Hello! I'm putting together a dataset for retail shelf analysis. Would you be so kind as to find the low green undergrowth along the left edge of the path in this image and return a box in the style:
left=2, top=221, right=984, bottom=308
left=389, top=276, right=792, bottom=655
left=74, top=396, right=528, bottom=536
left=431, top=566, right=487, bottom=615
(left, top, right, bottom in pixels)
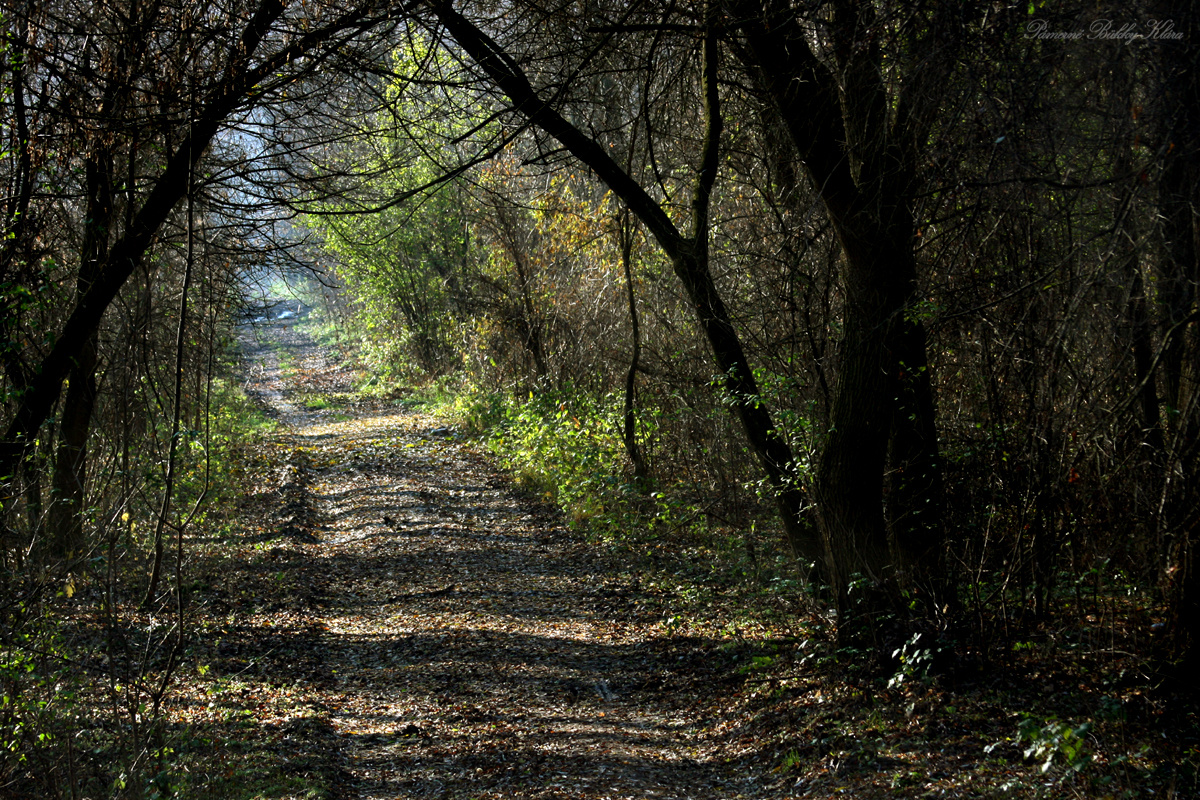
left=0, top=380, right=272, bottom=799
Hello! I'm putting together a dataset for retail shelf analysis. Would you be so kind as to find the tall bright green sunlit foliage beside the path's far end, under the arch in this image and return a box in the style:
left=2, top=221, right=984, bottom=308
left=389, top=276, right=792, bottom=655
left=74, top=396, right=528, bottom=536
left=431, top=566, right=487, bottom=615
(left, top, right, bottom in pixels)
left=301, top=37, right=494, bottom=377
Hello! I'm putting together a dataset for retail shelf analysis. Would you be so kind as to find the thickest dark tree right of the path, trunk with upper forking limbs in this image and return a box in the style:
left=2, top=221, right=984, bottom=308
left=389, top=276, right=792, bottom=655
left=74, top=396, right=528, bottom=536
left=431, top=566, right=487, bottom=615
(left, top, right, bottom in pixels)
left=732, top=0, right=950, bottom=627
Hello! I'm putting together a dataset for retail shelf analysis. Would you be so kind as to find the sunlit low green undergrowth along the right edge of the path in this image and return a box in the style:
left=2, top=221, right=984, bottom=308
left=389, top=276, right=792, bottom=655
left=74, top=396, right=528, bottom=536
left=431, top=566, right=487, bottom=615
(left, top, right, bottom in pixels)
left=432, top=385, right=800, bottom=593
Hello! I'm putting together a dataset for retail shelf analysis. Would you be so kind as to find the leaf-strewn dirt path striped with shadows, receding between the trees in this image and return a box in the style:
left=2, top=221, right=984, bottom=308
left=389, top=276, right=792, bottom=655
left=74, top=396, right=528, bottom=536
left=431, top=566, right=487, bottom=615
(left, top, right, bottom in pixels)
left=224, top=303, right=762, bottom=800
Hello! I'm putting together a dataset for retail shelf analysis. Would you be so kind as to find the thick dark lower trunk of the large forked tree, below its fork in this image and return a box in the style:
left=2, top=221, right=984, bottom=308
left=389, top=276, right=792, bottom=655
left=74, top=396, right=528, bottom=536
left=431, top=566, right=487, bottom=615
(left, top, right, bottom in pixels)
left=817, top=219, right=944, bottom=622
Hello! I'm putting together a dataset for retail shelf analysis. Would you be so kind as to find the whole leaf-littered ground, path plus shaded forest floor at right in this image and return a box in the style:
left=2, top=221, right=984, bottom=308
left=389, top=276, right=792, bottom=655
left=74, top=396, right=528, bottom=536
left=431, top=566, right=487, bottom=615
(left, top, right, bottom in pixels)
left=168, top=309, right=1200, bottom=800
